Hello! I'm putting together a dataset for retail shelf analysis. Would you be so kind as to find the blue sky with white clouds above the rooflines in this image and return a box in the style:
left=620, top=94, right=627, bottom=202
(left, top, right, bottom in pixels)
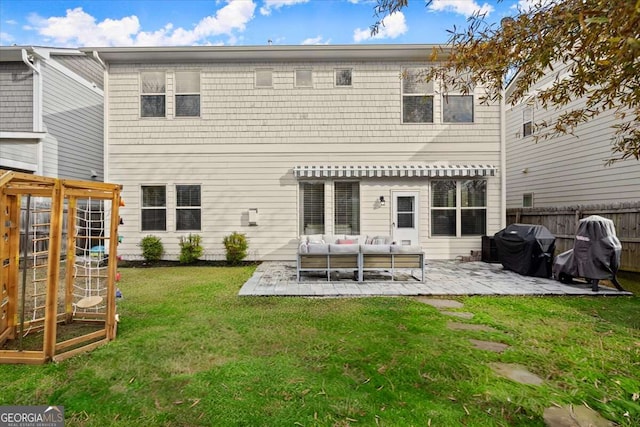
left=0, top=0, right=534, bottom=47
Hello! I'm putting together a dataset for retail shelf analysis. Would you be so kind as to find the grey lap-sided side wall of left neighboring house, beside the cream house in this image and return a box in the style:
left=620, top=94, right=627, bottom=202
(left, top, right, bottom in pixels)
left=41, top=63, right=104, bottom=180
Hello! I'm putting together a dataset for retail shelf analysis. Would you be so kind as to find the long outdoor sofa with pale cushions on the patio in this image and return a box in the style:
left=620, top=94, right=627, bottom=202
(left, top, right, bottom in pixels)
left=296, top=234, right=424, bottom=282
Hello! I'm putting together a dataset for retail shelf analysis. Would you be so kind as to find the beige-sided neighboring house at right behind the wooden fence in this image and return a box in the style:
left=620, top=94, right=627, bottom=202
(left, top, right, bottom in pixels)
left=505, top=62, right=640, bottom=211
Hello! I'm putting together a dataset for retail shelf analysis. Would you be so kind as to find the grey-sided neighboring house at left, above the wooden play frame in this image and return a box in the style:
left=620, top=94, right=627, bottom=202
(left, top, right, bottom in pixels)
left=0, top=46, right=104, bottom=181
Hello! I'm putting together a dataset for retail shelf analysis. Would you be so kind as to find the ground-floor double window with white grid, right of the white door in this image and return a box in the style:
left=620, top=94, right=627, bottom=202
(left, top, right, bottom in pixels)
left=431, top=179, right=487, bottom=237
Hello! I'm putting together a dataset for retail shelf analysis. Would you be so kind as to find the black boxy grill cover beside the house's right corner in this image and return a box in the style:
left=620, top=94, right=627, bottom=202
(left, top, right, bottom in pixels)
left=494, top=224, right=556, bottom=277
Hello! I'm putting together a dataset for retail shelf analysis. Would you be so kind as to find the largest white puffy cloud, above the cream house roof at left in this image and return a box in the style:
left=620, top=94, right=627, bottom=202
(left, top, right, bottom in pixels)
left=25, top=0, right=256, bottom=46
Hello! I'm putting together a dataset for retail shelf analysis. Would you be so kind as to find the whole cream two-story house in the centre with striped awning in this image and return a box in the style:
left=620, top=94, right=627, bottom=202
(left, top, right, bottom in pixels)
left=81, top=45, right=505, bottom=260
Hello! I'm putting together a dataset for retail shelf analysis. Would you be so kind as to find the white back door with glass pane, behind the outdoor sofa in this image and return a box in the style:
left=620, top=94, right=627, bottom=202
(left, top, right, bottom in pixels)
left=391, top=191, right=420, bottom=245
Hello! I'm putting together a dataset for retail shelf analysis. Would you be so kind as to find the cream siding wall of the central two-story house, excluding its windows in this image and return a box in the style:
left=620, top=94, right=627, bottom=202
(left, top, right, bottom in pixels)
left=106, top=54, right=501, bottom=260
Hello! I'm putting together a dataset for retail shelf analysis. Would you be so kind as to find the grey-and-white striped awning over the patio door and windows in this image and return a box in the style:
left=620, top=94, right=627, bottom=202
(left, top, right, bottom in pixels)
left=293, top=163, right=497, bottom=178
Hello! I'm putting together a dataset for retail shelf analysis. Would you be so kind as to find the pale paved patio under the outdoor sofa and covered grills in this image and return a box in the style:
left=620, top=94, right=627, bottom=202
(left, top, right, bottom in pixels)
left=239, top=260, right=633, bottom=297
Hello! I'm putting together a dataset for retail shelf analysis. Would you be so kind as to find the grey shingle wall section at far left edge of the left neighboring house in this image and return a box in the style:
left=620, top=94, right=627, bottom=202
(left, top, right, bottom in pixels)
left=0, top=62, right=33, bottom=132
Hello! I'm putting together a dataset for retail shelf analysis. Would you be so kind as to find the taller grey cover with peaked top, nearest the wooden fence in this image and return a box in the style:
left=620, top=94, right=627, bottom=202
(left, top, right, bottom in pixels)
left=553, top=215, right=622, bottom=280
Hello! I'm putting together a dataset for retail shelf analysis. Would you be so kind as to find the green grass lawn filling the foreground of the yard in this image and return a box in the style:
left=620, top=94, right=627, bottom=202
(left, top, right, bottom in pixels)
left=0, top=267, right=640, bottom=427
